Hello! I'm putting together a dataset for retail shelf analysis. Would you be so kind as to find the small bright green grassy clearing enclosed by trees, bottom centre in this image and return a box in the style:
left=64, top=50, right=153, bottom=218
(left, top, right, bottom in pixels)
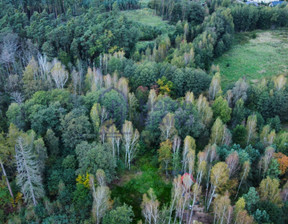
left=111, top=152, right=172, bottom=223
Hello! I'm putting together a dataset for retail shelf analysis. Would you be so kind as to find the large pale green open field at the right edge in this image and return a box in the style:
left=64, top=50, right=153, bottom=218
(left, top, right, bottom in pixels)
left=214, top=29, right=288, bottom=85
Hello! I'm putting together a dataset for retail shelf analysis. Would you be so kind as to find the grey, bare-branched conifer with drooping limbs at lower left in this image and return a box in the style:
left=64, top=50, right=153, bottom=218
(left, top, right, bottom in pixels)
left=15, top=137, right=44, bottom=206
